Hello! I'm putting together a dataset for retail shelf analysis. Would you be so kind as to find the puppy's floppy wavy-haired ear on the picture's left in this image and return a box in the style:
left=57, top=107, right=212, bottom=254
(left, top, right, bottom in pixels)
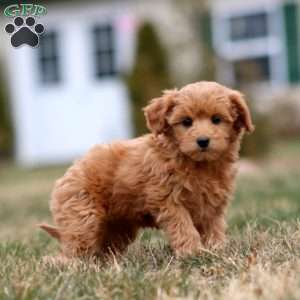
left=143, top=90, right=178, bottom=134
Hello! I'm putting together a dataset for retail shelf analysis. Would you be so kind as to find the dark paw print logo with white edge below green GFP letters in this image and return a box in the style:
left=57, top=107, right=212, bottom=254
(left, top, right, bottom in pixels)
left=5, top=17, right=45, bottom=47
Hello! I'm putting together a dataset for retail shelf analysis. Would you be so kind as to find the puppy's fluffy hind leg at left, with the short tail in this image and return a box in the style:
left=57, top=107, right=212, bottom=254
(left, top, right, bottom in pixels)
left=50, top=189, right=106, bottom=257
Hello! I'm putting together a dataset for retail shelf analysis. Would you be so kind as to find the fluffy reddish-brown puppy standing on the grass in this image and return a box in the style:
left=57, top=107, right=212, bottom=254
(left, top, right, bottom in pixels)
left=41, top=82, right=253, bottom=257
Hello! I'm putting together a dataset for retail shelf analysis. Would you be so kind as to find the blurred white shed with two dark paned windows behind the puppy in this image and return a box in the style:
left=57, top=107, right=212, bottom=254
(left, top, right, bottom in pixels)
left=1, top=2, right=136, bottom=166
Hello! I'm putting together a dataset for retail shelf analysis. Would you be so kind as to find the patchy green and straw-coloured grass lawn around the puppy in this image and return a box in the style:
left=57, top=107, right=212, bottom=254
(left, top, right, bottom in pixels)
left=0, top=141, right=300, bottom=300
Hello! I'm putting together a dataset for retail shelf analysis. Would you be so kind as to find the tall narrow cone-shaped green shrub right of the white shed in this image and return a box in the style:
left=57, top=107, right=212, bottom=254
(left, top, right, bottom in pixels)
left=127, top=23, right=171, bottom=135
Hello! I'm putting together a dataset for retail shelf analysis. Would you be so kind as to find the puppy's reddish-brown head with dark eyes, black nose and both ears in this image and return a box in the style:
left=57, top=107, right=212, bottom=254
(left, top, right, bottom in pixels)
left=144, top=82, right=254, bottom=161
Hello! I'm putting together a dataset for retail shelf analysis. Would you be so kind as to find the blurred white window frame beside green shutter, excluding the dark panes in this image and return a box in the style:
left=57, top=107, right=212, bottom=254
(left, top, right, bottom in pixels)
left=212, top=2, right=287, bottom=86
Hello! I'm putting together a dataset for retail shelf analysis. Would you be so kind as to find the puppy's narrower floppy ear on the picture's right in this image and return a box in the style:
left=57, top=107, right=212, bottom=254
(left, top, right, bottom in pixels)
left=229, top=91, right=254, bottom=133
